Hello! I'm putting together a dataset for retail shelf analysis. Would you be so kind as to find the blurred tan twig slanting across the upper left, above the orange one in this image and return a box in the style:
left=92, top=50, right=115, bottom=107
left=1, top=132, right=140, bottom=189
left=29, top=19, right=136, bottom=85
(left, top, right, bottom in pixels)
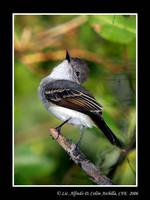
left=14, top=15, right=88, bottom=52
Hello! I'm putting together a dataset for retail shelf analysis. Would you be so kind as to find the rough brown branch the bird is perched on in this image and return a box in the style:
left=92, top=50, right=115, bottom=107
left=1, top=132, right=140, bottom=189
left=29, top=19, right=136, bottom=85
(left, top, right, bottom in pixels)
left=50, top=128, right=112, bottom=185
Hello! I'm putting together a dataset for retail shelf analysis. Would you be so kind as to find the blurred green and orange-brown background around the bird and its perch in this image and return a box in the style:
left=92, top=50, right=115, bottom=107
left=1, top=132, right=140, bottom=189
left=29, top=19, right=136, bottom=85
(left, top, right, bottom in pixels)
left=14, top=15, right=136, bottom=185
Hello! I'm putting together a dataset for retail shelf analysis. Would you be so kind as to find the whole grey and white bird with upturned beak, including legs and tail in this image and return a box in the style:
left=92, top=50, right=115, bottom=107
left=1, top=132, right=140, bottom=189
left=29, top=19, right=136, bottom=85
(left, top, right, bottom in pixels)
left=38, top=50, right=123, bottom=148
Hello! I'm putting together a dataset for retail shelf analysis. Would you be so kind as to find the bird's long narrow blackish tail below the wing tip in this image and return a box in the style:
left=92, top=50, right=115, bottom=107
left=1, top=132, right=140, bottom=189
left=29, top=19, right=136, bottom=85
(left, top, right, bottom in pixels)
left=91, top=113, right=124, bottom=148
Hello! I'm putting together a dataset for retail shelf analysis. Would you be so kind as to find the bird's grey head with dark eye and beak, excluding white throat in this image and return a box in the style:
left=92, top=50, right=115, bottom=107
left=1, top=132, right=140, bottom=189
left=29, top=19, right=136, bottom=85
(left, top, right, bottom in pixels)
left=66, top=51, right=88, bottom=84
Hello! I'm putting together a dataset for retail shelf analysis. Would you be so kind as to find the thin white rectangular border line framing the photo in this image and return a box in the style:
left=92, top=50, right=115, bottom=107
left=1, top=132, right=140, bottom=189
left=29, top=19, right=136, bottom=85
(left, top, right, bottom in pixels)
left=12, top=13, right=138, bottom=188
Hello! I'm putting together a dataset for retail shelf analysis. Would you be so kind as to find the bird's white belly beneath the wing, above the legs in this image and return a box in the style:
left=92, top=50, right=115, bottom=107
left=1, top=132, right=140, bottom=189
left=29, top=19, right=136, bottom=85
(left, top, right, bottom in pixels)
left=48, top=104, right=93, bottom=128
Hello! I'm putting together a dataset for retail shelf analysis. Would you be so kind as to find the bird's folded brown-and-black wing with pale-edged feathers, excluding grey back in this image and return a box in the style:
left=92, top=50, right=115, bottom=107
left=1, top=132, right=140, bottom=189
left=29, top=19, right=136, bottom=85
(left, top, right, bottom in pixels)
left=45, top=88, right=102, bottom=113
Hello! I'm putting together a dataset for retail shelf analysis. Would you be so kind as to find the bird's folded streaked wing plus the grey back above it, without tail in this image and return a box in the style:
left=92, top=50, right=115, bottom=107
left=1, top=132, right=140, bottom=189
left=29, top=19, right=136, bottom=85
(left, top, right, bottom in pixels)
left=44, top=81, right=102, bottom=114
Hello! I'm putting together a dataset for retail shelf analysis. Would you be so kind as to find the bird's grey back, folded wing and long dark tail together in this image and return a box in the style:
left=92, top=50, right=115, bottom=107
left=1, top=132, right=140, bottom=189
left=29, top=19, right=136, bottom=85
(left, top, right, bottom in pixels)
left=44, top=80, right=121, bottom=147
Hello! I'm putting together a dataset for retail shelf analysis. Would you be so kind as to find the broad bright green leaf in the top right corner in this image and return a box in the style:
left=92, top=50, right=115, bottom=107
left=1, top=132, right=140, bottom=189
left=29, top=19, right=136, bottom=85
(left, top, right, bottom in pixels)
left=89, top=15, right=136, bottom=44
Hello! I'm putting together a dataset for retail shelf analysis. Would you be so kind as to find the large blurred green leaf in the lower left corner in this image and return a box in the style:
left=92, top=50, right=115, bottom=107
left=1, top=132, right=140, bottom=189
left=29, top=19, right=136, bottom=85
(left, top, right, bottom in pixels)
left=15, top=152, right=56, bottom=184
